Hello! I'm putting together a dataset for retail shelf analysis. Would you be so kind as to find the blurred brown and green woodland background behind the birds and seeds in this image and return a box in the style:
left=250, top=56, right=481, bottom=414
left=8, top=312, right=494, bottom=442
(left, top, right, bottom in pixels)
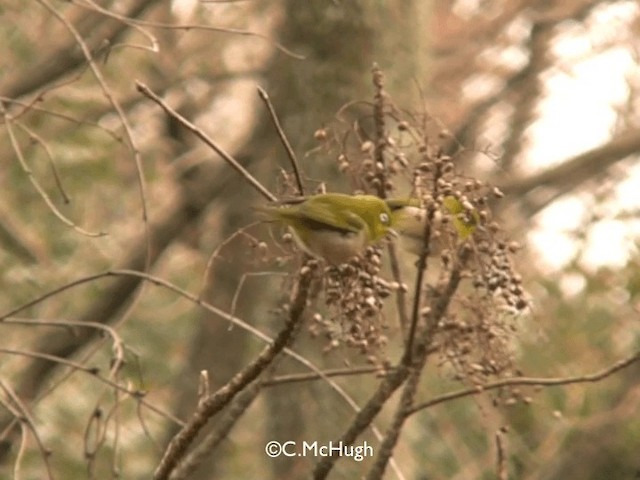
left=0, top=0, right=640, bottom=479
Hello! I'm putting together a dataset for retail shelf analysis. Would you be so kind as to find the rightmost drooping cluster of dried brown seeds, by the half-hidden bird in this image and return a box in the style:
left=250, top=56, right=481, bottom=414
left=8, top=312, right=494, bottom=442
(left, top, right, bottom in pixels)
left=415, top=163, right=528, bottom=384
